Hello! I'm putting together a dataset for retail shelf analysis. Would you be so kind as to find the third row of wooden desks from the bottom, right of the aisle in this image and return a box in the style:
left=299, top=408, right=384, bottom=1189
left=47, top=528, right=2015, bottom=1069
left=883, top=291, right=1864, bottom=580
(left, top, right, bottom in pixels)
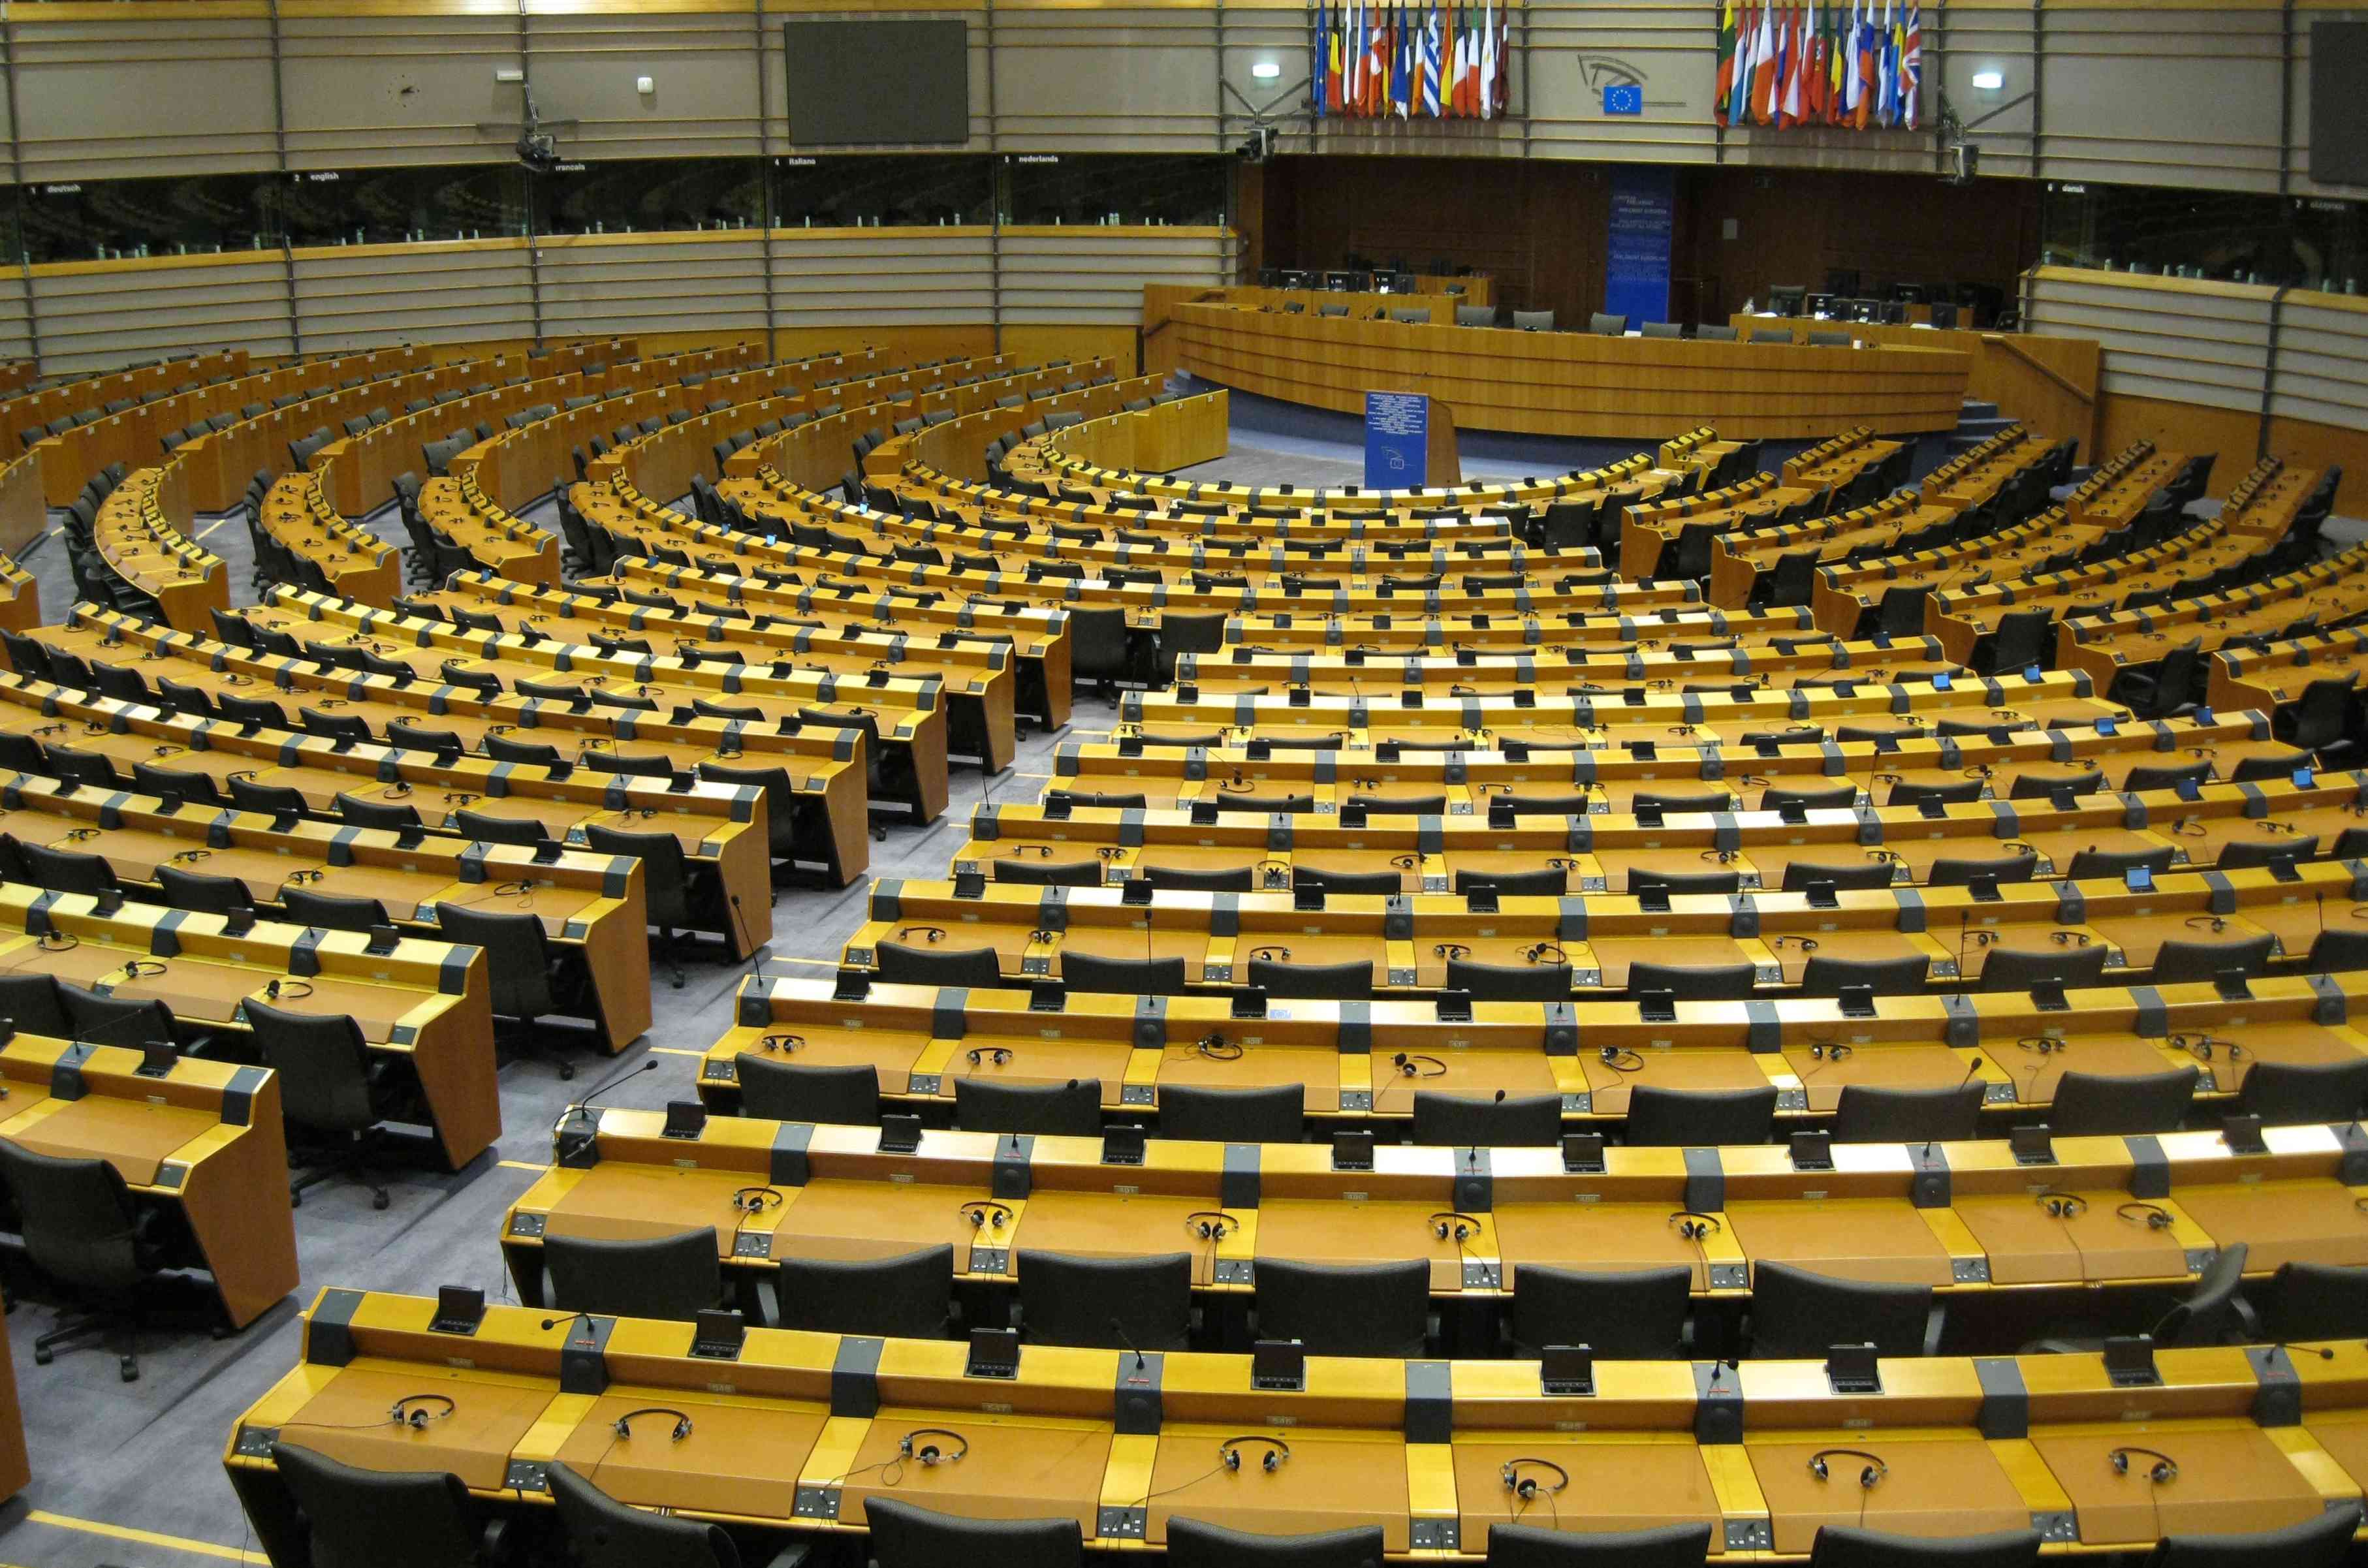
left=699, top=976, right=2363, bottom=1130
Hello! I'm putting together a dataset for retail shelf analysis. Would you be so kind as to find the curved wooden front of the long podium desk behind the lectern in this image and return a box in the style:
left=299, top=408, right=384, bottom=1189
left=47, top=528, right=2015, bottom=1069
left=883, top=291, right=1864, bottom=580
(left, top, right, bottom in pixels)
left=1172, top=306, right=1970, bottom=441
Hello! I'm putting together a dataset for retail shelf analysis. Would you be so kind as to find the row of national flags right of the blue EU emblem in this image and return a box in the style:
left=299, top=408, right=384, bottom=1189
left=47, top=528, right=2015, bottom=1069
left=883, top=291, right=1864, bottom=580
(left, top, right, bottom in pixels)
left=1712, top=0, right=1923, bottom=131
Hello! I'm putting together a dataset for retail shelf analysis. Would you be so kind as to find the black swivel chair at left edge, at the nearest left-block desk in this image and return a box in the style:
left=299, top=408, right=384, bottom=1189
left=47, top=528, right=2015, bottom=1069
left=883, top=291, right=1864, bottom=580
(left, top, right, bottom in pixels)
left=0, top=1139, right=163, bottom=1383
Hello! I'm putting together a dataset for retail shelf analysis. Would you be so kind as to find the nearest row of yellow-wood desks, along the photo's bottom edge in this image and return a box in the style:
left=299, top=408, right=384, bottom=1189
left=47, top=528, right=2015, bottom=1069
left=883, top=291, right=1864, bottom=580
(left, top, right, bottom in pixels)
left=223, top=1291, right=2368, bottom=1561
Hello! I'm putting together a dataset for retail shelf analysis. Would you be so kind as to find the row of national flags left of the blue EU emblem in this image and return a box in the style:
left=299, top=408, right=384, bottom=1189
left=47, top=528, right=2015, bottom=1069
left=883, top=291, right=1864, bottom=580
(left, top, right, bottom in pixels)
left=1307, top=0, right=1511, bottom=121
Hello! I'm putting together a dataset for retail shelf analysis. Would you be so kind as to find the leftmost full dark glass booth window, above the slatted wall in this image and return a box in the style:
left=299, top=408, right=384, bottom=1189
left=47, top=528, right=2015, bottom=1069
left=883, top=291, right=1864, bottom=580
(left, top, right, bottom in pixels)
left=12, top=176, right=279, bottom=265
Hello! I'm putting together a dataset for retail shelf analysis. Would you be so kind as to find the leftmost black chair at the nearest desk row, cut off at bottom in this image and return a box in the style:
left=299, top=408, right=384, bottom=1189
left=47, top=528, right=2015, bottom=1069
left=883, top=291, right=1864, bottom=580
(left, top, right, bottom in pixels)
left=272, top=1443, right=502, bottom=1568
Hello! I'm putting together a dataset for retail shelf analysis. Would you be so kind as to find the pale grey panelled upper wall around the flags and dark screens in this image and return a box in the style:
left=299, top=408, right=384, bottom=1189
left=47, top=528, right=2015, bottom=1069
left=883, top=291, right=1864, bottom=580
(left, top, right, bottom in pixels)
left=0, top=0, right=2368, bottom=196
